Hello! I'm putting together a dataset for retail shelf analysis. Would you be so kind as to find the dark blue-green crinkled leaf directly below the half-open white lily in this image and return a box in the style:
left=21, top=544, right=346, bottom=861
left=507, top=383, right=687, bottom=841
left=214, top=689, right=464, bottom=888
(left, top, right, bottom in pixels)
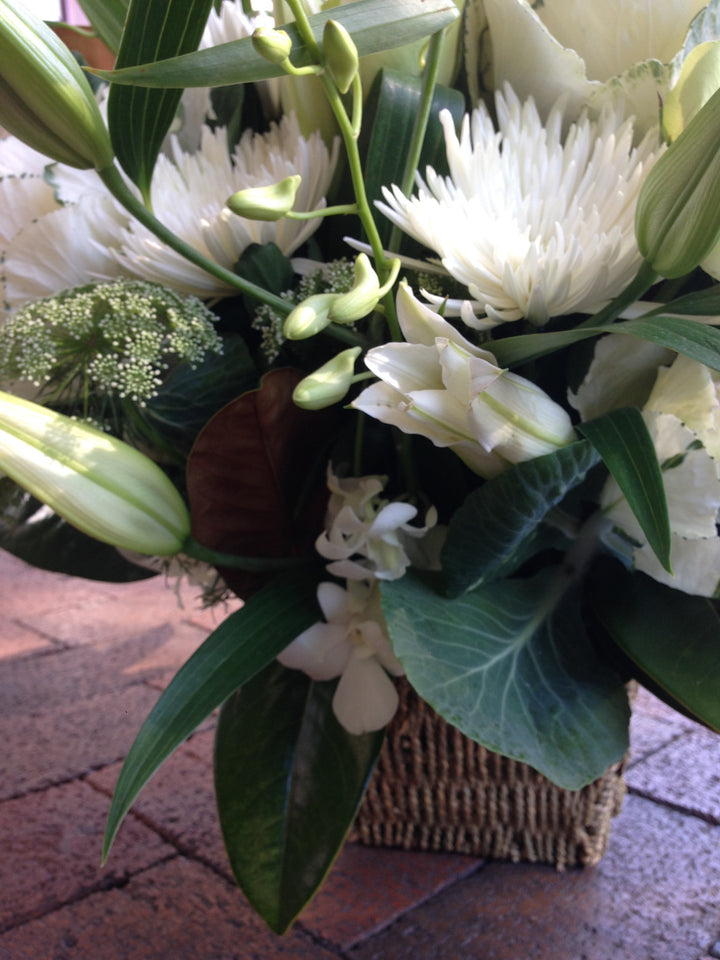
left=442, top=440, right=600, bottom=597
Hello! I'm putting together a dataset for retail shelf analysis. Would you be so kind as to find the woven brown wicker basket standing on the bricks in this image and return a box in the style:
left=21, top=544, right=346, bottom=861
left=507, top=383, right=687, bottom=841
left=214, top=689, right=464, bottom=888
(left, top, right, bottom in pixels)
left=350, top=683, right=625, bottom=869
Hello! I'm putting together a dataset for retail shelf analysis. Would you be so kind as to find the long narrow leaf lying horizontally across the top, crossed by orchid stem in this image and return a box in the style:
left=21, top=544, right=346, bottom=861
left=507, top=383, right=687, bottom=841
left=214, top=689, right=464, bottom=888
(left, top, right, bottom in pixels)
left=93, top=0, right=458, bottom=88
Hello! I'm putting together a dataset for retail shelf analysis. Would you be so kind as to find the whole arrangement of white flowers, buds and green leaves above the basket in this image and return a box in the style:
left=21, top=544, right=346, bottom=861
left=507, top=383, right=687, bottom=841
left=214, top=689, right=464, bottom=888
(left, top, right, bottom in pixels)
left=0, top=0, right=720, bottom=932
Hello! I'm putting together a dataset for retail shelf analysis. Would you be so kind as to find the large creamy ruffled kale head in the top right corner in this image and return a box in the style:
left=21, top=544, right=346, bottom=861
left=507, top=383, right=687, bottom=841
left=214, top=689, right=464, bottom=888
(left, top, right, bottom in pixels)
left=466, top=0, right=720, bottom=132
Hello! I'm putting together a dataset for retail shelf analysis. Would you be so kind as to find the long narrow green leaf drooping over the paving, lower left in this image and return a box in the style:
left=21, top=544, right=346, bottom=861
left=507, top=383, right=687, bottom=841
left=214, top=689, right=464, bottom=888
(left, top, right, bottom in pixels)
left=103, top=567, right=319, bottom=858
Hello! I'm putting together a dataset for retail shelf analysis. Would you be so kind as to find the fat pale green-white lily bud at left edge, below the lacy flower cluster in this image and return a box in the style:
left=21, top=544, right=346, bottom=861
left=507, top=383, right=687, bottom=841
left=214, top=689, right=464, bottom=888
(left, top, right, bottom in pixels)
left=0, top=392, right=190, bottom=556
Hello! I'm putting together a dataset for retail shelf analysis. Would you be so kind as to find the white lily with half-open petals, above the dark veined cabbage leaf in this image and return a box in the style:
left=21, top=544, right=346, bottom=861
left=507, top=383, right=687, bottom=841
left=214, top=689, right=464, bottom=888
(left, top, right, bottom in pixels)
left=353, top=284, right=575, bottom=477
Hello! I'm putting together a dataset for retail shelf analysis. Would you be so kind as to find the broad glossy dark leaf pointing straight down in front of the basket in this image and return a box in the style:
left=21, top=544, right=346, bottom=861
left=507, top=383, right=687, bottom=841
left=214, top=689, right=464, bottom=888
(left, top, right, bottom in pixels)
left=215, top=664, right=383, bottom=933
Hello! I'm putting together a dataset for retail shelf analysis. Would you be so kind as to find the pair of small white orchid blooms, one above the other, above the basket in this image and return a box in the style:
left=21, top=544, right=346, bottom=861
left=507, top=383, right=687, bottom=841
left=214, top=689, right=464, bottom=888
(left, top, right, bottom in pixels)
left=278, top=469, right=437, bottom=735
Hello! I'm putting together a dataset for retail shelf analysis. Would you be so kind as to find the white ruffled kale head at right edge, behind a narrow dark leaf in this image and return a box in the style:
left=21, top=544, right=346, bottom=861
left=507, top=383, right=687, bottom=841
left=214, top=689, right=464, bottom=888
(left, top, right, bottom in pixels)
left=570, top=334, right=720, bottom=597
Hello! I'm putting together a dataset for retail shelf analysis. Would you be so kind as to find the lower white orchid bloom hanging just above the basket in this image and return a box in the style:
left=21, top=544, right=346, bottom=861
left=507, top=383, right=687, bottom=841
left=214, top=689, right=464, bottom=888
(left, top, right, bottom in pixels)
left=278, top=580, right=404, bottom=735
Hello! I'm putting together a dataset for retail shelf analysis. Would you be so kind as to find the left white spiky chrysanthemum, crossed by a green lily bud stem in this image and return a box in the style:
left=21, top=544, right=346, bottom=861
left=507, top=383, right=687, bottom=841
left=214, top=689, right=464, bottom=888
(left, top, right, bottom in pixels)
left=116, top=116, right=338, bottom=298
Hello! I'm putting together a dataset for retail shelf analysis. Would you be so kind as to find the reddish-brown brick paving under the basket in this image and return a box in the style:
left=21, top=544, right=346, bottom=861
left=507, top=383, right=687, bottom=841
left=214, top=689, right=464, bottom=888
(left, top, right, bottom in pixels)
left=0, top=553, right=720, bottom=960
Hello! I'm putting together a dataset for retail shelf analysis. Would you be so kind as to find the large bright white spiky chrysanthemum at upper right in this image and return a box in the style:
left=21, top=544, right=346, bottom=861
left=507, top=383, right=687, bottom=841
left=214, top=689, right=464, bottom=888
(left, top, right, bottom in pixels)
left=377, top=87, right=661, bottom=326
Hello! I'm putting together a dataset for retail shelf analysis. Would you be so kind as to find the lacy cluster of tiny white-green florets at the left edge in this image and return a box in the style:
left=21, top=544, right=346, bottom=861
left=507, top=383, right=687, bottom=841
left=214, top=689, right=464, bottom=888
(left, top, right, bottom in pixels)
left=0, top=280, right=222, bottom=404
